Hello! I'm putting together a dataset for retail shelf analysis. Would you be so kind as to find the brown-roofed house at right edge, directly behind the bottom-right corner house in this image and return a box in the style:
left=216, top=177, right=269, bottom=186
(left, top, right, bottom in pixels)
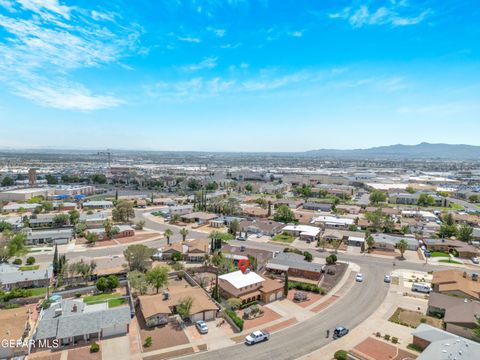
left=428, top=292, right=480, bottom=340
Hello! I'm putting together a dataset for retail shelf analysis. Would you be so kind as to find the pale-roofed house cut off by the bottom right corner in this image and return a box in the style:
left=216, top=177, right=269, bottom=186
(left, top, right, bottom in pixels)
left=412, top=324, right=480, bottom=360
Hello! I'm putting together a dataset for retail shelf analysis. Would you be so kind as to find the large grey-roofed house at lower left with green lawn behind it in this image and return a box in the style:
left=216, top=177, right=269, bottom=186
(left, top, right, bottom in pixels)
left=34, top=300, right=131, bottom=345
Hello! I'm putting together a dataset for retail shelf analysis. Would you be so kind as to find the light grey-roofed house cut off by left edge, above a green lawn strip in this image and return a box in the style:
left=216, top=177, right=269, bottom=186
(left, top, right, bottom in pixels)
left=0, top=263, right=53, bottom=291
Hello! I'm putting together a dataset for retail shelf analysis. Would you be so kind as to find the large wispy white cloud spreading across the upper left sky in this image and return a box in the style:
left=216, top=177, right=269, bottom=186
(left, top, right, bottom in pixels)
left=0, top=0, right=144, bottom=110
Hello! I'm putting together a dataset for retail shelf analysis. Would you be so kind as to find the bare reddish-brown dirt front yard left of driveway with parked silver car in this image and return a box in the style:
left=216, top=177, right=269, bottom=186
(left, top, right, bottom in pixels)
left=137, top=311, right=189, bottom=352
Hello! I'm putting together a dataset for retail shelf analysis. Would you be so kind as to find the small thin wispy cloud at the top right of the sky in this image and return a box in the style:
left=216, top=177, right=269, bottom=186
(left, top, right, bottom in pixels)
left=328, top=1, right=432, bottom=28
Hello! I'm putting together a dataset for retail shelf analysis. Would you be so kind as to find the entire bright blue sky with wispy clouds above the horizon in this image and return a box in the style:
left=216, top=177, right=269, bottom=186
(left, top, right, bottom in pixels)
left=0, top=0, right=480, bottom=151
